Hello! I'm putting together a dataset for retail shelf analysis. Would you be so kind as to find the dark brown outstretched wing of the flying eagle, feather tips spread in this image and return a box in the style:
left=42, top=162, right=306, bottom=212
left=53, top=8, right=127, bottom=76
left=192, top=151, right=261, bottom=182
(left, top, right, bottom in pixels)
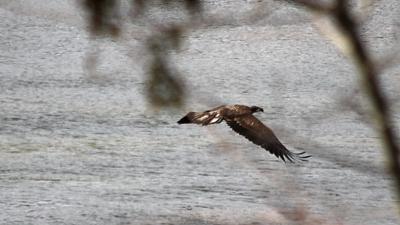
left=226, top=114, right=311, bottom=162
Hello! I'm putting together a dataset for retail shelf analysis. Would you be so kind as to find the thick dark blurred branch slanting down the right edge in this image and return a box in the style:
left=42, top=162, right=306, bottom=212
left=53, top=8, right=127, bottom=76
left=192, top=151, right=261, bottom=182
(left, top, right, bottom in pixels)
left=289, top=0, right=400, bottom=209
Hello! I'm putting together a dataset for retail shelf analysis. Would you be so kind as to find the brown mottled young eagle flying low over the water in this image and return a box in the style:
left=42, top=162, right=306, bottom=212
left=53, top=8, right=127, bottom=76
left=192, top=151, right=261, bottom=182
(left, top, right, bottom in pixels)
left=178, top=105, right=311, bottom=162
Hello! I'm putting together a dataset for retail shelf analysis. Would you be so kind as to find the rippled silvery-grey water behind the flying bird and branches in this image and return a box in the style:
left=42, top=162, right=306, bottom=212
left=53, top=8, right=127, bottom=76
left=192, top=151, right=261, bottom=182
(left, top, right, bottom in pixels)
left=0, top=0, right=400, bottom=225
